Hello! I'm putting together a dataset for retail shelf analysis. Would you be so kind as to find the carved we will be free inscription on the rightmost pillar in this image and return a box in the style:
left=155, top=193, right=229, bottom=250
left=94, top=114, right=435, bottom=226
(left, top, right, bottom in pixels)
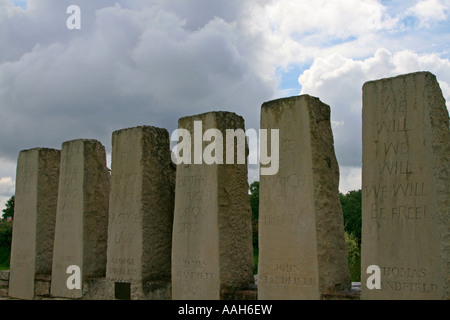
left=363, top=90, right=431, bottom=221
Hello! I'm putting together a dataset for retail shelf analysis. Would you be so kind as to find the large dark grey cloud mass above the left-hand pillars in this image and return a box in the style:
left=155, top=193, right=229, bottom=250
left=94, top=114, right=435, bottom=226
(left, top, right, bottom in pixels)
left=0, top=0, right=277, bottom=159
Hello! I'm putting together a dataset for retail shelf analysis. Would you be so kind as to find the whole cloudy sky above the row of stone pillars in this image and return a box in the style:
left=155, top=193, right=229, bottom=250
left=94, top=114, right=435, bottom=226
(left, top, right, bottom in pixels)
left=0, top=0, right=450, bottom=208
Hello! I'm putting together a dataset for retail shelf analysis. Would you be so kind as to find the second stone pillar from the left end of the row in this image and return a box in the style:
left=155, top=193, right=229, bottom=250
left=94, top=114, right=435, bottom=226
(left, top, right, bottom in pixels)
left=51, top=139, right=110, bottom=298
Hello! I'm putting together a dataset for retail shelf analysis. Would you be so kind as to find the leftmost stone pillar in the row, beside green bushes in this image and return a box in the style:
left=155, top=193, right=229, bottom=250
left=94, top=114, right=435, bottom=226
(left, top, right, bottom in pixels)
left=9, top=148, right=60, bottom=299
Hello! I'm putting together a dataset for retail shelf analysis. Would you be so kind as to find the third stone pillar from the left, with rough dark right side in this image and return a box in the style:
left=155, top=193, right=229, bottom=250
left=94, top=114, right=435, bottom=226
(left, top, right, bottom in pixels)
left=106, top=126, right=175, bottom=299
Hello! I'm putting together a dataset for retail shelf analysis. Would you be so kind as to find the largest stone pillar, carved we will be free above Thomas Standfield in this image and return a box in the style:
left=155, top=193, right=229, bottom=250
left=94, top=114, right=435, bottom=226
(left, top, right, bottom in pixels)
left=361, top=72, right=450, bottom=299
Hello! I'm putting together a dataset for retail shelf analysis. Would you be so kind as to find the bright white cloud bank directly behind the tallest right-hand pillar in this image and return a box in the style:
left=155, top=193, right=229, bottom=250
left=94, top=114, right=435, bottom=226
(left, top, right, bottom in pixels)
left=299, top=49, right=450, bottom=188
